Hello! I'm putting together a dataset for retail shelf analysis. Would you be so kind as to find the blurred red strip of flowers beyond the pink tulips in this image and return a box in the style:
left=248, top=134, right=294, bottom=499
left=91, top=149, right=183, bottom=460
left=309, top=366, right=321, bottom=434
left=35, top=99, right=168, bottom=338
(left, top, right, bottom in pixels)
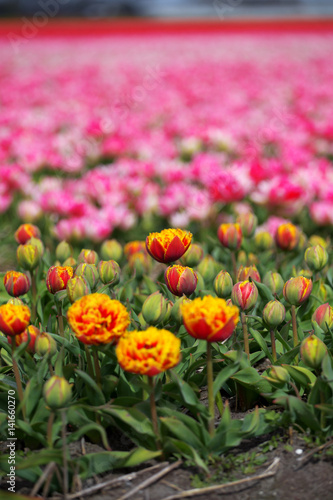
left=0, top=17, right=333, bottom=37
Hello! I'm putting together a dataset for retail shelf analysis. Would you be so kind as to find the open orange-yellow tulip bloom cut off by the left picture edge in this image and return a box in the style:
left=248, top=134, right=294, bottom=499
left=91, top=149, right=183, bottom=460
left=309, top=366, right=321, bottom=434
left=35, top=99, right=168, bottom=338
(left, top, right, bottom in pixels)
left=0, top=304, right=31, bottom=337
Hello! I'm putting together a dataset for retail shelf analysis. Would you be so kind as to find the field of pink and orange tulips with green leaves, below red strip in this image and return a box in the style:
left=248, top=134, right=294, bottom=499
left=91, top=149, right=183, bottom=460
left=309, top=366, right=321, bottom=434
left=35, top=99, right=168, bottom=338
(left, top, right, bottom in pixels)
left=0, top=26, right=333, bottom=500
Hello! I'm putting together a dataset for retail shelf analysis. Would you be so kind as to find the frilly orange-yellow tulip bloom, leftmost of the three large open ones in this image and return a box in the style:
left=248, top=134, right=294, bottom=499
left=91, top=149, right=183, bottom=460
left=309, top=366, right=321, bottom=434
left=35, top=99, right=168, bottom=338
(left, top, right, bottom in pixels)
left=67, top=293, right=130, bottom=345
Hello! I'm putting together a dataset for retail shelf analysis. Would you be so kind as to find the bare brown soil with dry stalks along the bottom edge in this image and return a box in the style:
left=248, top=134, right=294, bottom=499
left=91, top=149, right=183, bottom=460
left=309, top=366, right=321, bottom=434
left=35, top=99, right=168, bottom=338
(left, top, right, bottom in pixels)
left=0, top=432, right=333, bottom=500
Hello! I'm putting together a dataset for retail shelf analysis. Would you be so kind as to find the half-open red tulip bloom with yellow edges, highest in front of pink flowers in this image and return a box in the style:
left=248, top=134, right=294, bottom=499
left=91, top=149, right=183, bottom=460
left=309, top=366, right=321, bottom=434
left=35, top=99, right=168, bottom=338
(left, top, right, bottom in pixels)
left=146, top=229, right=192, bottom=264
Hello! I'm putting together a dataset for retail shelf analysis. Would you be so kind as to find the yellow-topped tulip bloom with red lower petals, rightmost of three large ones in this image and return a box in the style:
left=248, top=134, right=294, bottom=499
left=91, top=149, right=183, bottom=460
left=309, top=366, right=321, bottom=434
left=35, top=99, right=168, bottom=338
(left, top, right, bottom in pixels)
left=181, top=295, right=239, bottom=342
